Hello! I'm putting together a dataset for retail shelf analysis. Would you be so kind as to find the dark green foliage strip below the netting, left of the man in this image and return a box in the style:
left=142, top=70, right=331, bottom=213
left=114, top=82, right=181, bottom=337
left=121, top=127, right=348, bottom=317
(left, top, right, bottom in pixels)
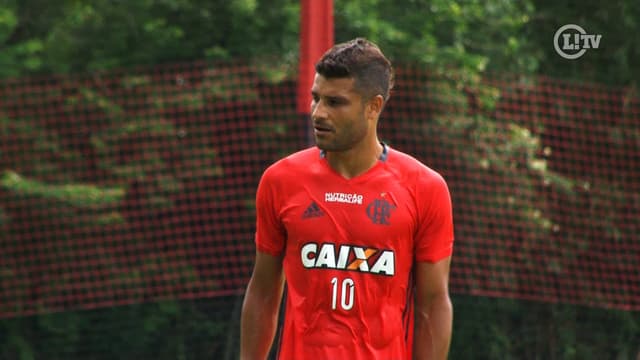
left=0, top=298, right=238, bottom=360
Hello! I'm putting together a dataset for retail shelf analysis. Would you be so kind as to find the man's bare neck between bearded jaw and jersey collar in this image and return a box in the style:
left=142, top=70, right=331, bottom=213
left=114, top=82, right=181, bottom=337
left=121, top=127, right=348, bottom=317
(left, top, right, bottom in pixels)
left=325, top=137, right=383, bottom=179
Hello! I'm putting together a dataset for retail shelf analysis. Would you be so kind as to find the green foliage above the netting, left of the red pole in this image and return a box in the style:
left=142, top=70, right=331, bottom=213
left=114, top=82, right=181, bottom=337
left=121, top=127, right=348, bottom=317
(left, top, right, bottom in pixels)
left=0, top=0, right=299, bottom=77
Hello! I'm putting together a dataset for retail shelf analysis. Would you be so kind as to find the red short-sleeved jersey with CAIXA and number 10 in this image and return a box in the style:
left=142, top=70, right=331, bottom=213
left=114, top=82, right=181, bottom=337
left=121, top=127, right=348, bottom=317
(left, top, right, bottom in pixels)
left=256, top=146, right=453, bottom=360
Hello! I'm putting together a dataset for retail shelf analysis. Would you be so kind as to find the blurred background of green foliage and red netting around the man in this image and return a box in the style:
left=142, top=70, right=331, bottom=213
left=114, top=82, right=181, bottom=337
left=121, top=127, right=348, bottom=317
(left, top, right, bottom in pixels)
left=0, top=0, right=640, bottom=360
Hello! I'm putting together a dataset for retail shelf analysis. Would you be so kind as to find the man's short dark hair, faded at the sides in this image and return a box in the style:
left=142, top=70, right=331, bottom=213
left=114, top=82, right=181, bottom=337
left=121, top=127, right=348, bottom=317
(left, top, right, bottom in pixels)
left=316, top=38, right=394, bottom=102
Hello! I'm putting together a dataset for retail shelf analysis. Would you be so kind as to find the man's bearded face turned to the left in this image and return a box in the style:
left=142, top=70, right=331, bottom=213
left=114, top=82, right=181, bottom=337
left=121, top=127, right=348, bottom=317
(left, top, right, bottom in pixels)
left=311, top=74, right=371, bottom=151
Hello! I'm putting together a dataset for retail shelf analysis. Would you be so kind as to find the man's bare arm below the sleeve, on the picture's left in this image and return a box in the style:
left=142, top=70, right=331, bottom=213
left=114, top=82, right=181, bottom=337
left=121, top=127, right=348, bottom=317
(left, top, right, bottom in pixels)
left=240, top=251, right=284, bottom=360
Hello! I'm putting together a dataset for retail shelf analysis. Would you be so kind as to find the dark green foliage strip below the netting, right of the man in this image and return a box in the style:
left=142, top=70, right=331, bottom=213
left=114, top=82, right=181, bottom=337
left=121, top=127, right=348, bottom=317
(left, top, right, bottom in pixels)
left=450, top=296, right=640, bottom=360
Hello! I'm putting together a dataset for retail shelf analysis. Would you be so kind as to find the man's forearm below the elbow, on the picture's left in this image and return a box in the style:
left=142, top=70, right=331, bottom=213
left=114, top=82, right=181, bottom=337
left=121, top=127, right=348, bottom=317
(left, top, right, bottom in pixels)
left=240, top=290, right=279, bottom=360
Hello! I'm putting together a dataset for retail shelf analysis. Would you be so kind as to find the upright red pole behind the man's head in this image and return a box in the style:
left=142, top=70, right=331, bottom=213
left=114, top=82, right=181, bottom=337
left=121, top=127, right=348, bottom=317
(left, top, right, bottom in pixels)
left=297, top=0, right=334, bottom=115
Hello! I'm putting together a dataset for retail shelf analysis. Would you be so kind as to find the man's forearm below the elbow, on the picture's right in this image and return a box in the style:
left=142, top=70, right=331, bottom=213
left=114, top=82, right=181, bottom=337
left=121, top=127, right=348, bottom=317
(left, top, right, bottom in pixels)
left=413, top=295, right=453, bottom=360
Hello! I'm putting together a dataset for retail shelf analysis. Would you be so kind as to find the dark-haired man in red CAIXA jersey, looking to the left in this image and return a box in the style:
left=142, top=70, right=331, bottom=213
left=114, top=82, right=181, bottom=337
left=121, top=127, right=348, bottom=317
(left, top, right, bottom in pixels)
left=240, top=38, right=453, bottom=360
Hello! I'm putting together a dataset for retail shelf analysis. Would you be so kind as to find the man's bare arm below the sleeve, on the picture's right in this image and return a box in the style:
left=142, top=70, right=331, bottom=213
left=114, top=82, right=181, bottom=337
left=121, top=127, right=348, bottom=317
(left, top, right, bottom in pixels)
left=413, top=257, right=453, bottom=360
